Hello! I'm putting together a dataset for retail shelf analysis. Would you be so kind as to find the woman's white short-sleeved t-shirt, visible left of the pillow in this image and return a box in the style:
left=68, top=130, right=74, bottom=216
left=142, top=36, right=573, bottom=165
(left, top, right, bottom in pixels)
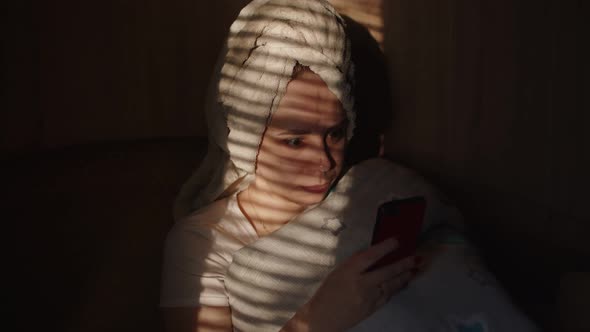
left=160, top=194, right=258, bottom=307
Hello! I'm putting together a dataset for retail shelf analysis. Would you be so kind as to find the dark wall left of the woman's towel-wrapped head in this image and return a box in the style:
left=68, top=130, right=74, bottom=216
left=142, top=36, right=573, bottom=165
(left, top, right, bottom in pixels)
left=0, top=0, right=252, bottom=150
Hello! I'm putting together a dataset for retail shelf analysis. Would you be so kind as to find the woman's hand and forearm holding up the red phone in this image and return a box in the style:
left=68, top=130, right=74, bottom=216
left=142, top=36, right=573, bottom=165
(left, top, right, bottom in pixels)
left=284, top=239, right=421, bottom=331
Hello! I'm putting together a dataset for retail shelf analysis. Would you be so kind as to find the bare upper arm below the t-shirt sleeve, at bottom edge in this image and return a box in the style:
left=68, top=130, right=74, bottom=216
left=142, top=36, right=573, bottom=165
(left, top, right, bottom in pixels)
left=162, top=306, right=232, bottom=332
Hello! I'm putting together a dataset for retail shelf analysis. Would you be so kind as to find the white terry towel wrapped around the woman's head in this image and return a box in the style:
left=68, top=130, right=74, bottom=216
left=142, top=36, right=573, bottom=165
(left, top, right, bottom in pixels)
left=174, top=0, right=354, bottom=220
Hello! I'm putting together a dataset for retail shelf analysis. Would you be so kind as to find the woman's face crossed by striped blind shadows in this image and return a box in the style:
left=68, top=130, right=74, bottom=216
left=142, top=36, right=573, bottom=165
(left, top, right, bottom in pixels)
left=256, top=70, right=348, bottom=206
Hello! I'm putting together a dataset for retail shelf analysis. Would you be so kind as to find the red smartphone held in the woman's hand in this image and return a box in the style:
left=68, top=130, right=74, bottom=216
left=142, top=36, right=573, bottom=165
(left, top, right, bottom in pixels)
left=369, top=196, right=426, bottom=270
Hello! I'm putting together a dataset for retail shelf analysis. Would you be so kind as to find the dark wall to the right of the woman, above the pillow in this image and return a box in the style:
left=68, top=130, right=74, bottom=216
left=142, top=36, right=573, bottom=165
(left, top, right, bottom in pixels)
left=384, top=0, right=590, bottom=286
